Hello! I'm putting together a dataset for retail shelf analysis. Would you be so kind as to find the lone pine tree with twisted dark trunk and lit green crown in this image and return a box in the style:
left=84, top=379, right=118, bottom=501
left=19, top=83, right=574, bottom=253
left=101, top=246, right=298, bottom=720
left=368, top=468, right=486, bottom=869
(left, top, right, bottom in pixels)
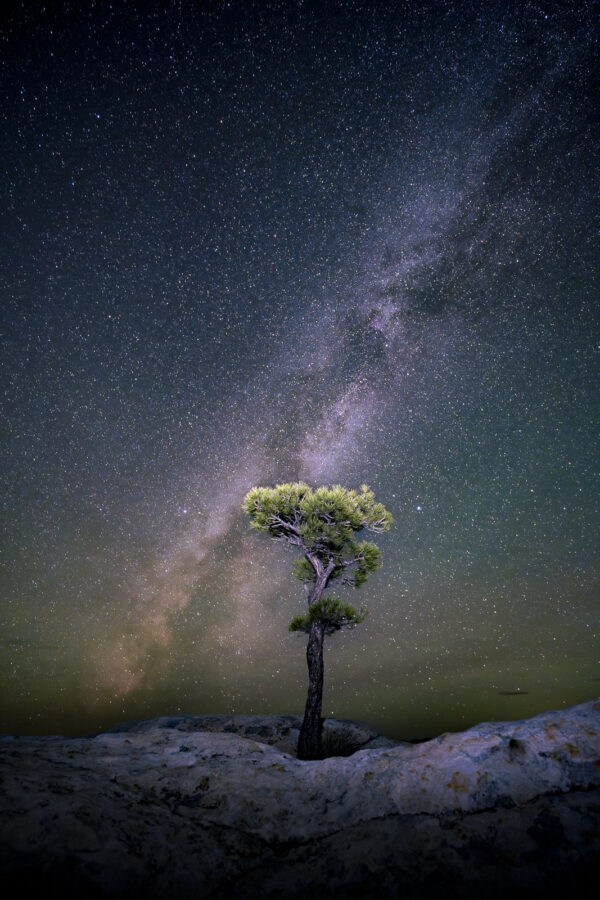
left=244, top=482, right=393, bottom=759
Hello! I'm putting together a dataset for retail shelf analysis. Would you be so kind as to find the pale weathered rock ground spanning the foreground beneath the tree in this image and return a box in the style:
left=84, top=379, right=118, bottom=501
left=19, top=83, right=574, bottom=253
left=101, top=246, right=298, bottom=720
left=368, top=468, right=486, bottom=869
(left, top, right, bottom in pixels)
left=0, top=702, right=600, bottom=900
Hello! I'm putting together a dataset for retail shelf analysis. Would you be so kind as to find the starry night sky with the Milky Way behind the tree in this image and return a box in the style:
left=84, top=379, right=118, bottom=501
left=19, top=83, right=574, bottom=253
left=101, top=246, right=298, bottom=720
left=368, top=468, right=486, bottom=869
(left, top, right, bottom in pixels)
left=0, top=0, right=600, bottom=738
